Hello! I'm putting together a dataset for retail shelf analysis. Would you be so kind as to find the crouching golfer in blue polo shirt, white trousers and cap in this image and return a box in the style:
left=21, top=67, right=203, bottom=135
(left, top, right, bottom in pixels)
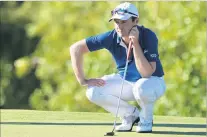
left=70, top=2, right=166, bottom=133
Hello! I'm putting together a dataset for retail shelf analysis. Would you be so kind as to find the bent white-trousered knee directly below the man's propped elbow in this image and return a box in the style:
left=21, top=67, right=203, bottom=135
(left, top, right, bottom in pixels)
left=133, top=78, right=156, bottom=103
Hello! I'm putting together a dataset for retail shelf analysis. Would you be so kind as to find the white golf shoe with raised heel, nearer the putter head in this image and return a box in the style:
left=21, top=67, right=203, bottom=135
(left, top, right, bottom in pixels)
left=116, top=108, right=139, bottom=132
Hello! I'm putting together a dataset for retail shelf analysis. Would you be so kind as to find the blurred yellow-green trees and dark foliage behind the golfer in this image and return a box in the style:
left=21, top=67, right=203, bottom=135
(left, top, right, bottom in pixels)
left=0, top=1, right=206, bottom=117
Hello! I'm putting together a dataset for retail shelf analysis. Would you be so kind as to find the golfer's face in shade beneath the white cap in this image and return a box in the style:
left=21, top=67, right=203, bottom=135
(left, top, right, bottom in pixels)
left=114, top=18, right=136, bottom=37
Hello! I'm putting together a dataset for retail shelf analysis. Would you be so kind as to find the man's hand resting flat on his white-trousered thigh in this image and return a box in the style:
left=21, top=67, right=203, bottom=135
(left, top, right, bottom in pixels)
left=80, top=78, right=106, bottom=87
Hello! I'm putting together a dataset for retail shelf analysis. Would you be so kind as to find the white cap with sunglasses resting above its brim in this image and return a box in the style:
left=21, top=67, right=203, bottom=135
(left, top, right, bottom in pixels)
left=109, top=2, right=139, bottom=21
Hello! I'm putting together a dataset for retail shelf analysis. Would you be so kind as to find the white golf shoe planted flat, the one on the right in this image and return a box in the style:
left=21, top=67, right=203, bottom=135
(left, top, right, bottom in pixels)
left=136, top=121, right=153, bottom=133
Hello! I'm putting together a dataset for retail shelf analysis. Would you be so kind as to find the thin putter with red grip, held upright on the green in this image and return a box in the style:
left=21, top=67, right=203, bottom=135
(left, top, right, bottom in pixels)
left=104, top=40, right=132, bottom=136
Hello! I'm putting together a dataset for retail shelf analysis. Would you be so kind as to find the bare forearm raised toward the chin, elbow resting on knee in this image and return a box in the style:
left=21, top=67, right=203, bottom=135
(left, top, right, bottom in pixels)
left=133, top=43, right=154, bottom=78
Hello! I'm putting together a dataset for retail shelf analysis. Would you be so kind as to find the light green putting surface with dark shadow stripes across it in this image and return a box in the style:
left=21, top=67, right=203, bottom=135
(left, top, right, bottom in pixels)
left=0, top=109, right=206, bottom=137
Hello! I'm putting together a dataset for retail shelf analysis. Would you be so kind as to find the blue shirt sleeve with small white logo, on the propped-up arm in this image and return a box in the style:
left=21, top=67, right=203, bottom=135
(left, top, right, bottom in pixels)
left=143, top=30, right=159, bottom=62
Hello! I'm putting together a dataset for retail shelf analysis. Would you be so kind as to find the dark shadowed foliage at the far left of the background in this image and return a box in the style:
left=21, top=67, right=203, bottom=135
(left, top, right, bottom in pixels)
left=0, top=2, right=39, bottom=108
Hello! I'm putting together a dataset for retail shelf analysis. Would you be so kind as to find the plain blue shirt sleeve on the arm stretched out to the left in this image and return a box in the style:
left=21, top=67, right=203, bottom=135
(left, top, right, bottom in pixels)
left=86, top=31, right=113, bottom=52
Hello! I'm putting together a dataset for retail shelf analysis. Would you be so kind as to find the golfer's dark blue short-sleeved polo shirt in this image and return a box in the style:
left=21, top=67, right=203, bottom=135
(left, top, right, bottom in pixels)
left=86, top=26, right=164, bottom=82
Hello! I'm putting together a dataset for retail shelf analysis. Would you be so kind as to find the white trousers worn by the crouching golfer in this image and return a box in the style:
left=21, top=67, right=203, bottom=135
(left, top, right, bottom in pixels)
left=86, top=74, right=166, bottom=122
